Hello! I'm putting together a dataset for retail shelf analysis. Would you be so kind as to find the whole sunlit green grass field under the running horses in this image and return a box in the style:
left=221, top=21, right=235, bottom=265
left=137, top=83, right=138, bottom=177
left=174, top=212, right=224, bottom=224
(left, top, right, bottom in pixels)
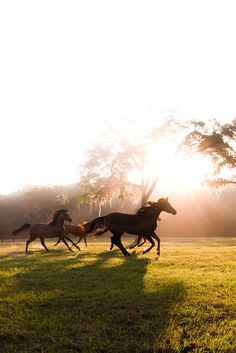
left=0, top=238, right=236, bottom=353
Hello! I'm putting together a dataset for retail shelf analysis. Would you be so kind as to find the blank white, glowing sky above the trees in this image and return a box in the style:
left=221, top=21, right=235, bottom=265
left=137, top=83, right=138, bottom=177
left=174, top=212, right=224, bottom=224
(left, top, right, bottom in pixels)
left=0, top=0, right=236, bottom=194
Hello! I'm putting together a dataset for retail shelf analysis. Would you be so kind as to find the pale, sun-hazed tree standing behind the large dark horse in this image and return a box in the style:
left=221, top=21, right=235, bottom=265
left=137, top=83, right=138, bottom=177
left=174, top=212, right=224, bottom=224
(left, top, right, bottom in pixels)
left=80, top=117, right=180, bottom=208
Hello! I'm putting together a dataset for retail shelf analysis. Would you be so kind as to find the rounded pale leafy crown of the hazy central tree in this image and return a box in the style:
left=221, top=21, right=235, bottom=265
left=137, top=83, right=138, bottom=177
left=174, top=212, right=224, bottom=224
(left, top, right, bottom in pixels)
left=82, top=141, right=143, bottom=202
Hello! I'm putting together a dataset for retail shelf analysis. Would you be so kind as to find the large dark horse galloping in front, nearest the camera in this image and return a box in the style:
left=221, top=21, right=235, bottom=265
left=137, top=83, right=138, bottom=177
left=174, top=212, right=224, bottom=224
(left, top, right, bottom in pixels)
left=84, top=198, right=177, bottom=256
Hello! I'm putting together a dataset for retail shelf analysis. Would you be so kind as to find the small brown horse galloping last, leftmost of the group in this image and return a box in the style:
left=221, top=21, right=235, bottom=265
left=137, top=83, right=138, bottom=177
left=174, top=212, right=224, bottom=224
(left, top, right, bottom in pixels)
left=12, top=209, right=80, bottom=252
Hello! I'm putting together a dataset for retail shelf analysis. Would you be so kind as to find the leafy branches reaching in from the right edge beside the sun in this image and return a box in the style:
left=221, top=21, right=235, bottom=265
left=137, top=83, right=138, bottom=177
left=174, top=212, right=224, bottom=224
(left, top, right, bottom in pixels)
left=180, top=119, right=236, bottom=187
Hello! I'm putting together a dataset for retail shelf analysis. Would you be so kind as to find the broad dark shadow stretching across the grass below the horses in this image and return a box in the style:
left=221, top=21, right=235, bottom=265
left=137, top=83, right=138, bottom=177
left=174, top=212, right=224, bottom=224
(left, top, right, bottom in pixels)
left=0, top=251, right=185, bottom=353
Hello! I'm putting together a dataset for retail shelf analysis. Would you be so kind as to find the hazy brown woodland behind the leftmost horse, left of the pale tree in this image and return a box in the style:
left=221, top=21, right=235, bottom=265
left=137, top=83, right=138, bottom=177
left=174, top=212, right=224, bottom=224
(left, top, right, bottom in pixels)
left=0, top=185, right=92, bottom=239
